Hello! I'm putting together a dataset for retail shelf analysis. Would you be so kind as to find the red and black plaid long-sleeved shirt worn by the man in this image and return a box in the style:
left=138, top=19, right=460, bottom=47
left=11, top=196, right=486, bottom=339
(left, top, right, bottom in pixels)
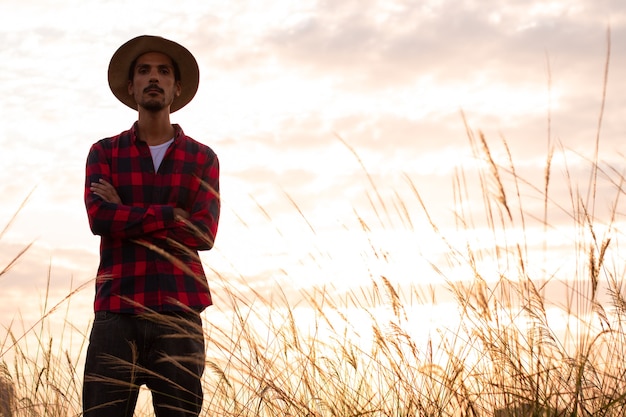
left=85, top=124, right=220, bottom=314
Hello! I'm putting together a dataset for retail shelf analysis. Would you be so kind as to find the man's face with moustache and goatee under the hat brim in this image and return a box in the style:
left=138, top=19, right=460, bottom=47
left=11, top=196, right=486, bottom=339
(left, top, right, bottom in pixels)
left=128, top=52, right=181, bottom=112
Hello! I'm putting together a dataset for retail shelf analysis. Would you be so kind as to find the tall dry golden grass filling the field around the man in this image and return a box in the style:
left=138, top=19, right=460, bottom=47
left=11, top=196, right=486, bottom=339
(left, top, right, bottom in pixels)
left=0, top=48, right=626, bottom=417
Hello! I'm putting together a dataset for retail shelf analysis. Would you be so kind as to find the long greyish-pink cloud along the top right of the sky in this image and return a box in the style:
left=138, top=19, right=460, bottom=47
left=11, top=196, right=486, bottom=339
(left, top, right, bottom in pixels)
left=256, top=1, right=624, bottom=87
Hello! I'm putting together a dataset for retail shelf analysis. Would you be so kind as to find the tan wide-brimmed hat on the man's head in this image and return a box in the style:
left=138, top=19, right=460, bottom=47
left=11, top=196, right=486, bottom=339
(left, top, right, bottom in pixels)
left=108, top=35, right=200, bottom=113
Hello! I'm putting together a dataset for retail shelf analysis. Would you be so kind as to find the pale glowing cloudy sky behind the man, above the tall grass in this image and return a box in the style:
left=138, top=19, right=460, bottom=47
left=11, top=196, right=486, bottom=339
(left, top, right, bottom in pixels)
left=0, top=0, right=626, bottom=344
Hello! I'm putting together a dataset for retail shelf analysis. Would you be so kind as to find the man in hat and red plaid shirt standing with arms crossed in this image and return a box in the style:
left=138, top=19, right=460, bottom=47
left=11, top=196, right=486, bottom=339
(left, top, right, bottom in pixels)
left=83, top=36, right=220, bottom=417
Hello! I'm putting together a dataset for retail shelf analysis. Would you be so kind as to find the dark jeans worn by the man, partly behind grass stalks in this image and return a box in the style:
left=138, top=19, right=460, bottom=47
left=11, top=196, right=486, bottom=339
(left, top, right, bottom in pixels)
left=83, top=312, right=205, bottom=417
